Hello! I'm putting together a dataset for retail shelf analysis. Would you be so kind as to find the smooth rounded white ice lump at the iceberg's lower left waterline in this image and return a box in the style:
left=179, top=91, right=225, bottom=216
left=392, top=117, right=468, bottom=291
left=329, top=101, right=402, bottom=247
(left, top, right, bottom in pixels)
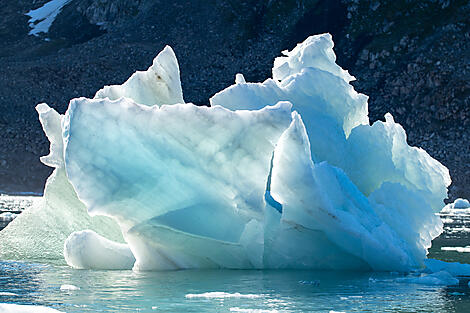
left=61, top=230, right=135, bottom=270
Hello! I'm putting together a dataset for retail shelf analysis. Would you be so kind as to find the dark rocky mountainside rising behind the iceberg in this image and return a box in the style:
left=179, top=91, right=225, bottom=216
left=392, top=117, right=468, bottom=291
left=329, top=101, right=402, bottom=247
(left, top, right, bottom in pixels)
left=0, top=0, right=470, bottom=198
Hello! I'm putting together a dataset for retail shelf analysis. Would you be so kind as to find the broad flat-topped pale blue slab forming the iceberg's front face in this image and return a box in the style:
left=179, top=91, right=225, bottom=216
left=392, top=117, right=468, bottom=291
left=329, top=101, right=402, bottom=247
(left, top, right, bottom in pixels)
left=64, top=98, right=291, bottom=270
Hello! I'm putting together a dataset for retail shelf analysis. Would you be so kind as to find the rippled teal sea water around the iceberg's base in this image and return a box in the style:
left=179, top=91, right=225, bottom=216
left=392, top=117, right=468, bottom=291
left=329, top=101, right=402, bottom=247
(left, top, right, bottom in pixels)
left=0, top=196, right=470, bottom=312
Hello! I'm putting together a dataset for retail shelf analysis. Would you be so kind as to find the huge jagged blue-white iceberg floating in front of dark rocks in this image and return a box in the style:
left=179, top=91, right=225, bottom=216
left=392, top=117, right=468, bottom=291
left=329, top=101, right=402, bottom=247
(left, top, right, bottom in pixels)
left=0, top=35, right=450, bottom=271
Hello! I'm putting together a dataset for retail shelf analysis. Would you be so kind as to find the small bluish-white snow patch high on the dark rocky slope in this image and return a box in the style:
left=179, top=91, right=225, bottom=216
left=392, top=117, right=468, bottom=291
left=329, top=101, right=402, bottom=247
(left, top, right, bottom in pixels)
left=26, top=0, right=71, bottom=36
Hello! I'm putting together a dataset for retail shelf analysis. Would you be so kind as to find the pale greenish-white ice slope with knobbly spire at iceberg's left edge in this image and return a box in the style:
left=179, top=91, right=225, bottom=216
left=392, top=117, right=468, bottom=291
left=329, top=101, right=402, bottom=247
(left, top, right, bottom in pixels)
left=0, top=104, right=123, bottom=263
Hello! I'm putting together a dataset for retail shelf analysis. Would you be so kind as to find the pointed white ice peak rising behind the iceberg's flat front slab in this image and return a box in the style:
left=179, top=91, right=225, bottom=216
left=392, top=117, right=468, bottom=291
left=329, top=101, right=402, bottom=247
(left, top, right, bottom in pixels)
left=95, top=46, right=184, bottom=105
